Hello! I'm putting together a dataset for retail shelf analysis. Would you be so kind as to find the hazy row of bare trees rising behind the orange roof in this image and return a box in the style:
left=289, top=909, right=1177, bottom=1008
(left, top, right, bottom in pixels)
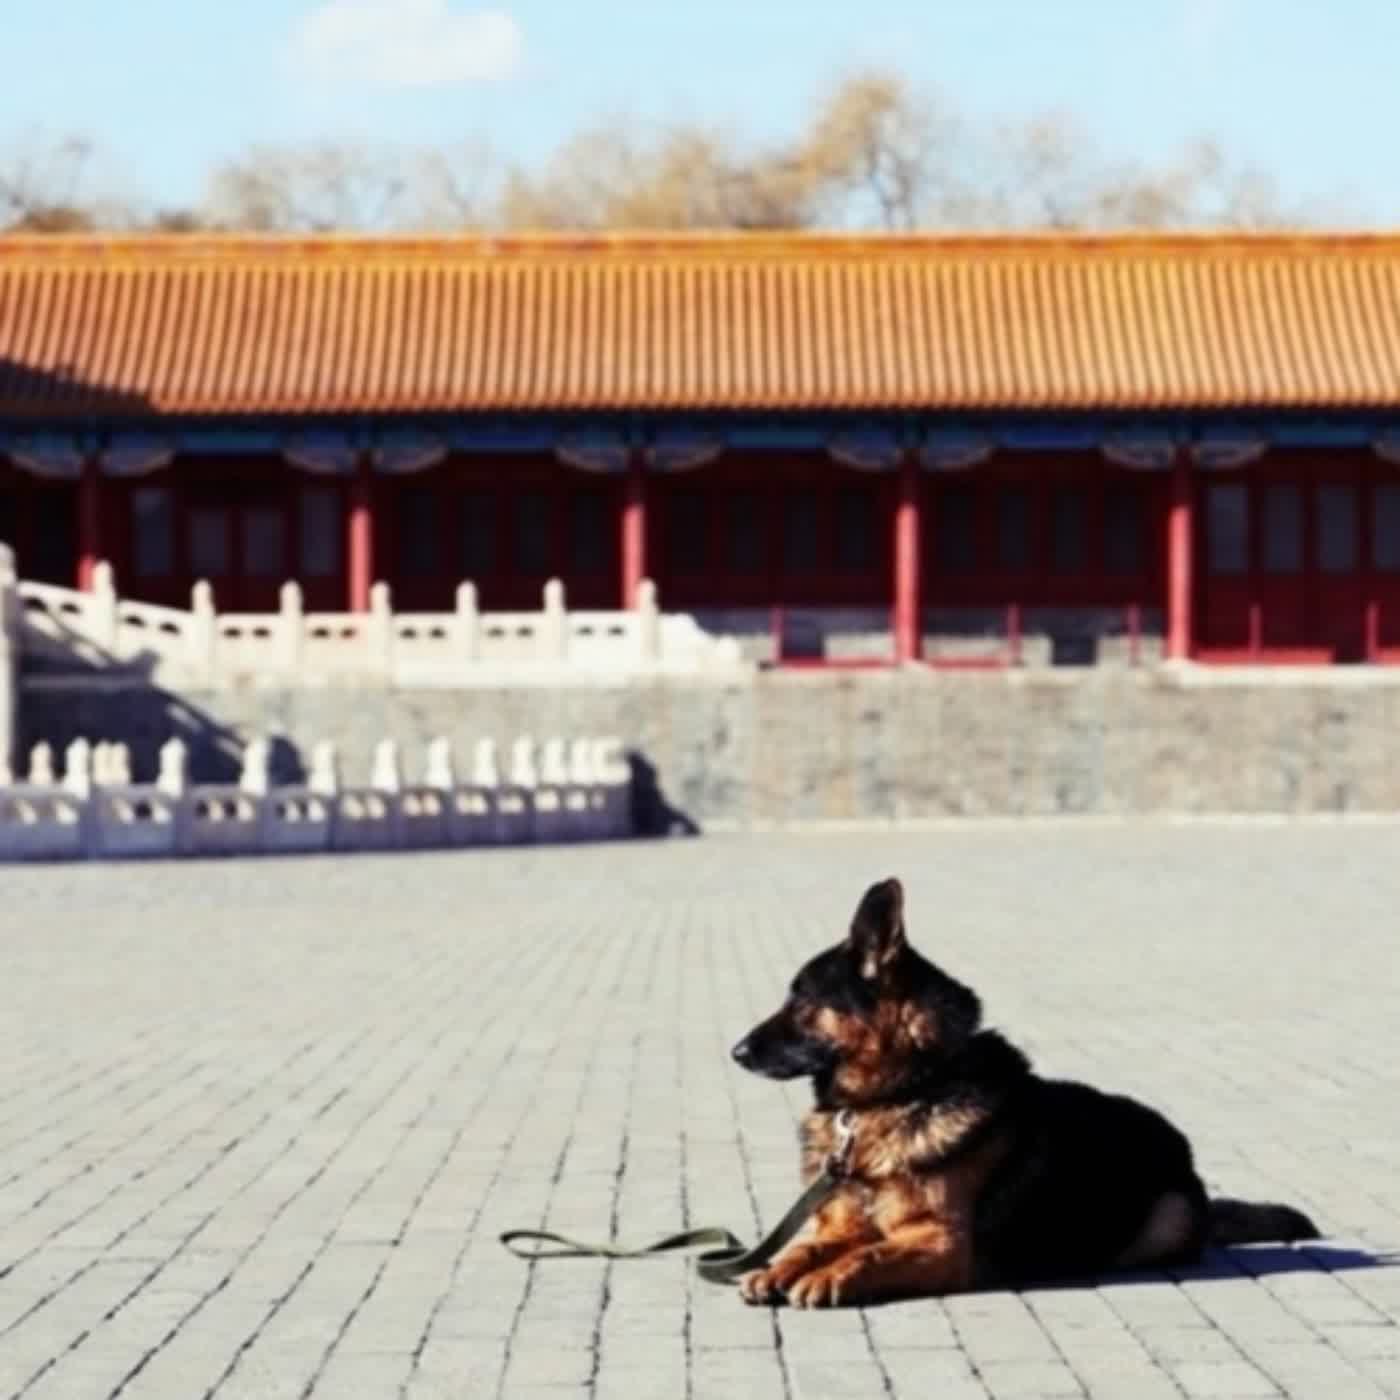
left=0, top=69, right=1303, bottom=232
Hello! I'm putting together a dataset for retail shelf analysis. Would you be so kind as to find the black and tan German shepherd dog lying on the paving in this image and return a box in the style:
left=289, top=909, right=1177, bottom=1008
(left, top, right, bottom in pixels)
left=734, top=879, right=1317, bottom=1308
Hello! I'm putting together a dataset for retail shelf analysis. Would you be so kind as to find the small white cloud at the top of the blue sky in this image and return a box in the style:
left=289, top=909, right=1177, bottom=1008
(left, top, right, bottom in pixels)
left=293, top=0, right=522, bottom=87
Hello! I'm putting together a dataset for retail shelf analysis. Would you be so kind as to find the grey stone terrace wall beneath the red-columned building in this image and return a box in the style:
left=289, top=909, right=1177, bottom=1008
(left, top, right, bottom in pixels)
left=21, top=668, right=1400, bottom=827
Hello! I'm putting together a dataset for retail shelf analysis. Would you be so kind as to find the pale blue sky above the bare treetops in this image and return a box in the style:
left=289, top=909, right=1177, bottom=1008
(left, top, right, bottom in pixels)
left=0, top=0, right=1400, bottom=224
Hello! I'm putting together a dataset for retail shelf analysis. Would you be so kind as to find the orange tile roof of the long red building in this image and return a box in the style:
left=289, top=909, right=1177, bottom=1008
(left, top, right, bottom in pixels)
left=0, top=226, right=1400, bottom=420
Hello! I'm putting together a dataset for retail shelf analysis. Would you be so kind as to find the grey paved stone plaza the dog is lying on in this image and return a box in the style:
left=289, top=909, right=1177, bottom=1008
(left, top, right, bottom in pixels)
left=0, top=823, right=1400, bottom=1400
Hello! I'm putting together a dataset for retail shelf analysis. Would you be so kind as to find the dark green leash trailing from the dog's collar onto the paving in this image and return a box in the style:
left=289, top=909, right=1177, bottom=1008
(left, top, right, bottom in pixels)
left=501, top=1109, right=855, bottom=1284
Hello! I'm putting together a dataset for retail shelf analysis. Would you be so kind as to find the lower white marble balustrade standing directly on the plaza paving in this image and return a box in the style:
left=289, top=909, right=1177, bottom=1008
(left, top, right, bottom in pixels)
left=0, top=735, right=634, bottom=862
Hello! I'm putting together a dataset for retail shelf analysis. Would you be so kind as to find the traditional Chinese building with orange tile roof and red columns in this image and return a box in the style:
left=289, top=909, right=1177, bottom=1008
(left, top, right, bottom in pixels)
left=0, top=226, right=1400, bottom=661
